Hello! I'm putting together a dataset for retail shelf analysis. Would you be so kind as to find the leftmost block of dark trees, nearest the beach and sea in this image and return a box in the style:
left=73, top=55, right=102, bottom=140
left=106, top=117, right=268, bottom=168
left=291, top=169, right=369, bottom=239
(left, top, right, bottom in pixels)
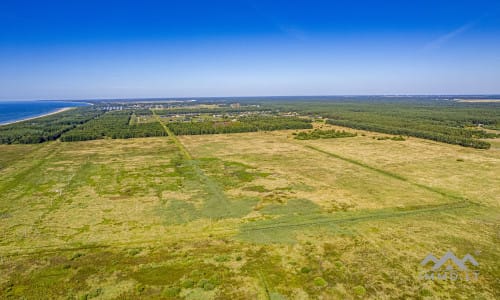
left=0, top=107, right=103, bottom=144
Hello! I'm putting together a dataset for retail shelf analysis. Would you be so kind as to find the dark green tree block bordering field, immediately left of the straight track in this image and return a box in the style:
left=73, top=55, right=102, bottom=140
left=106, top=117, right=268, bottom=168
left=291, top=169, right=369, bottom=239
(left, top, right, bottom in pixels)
left=61, top=110, right=166, bottom=142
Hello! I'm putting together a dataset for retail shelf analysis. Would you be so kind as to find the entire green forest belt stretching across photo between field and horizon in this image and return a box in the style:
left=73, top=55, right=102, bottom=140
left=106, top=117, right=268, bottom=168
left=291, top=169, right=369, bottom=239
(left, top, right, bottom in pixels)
left=0, top=97, right=500, bottom=149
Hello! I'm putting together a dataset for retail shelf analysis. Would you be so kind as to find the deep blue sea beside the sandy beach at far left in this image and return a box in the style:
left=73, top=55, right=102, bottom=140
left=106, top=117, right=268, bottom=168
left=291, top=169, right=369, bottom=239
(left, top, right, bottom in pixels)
left=0, top=100, right=88, bottom=125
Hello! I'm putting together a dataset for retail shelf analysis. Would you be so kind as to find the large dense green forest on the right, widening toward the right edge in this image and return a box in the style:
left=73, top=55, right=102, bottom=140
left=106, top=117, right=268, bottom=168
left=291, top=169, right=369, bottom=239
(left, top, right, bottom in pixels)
left=263, top=98, right=500, bottom=149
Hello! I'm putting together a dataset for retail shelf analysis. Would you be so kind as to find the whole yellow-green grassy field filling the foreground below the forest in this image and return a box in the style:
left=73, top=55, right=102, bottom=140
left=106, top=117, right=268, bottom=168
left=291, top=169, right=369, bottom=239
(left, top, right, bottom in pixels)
left=0, top=123, right=500, bottom=299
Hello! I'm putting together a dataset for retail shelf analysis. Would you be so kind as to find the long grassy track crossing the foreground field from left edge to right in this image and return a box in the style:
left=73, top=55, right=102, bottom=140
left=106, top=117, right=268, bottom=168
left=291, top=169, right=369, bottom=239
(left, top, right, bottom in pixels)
left=2, top=198, right=477, bottom=257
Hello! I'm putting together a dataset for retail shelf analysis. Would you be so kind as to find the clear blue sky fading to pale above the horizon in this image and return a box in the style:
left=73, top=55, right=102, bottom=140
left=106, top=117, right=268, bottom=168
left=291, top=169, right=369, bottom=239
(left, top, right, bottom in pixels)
left=0, top=0, right=500, bottom=100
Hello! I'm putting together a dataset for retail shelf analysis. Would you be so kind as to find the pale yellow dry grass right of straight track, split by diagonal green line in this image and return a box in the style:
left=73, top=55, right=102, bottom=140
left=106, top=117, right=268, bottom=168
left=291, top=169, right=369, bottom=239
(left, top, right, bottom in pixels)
left=180, top=125, right=500, bottom=209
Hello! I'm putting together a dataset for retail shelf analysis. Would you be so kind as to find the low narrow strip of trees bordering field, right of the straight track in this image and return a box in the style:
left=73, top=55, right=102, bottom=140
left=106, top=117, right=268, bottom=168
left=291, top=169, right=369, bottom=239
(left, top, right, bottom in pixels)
left=167, top=116, right=312, bottom=135
